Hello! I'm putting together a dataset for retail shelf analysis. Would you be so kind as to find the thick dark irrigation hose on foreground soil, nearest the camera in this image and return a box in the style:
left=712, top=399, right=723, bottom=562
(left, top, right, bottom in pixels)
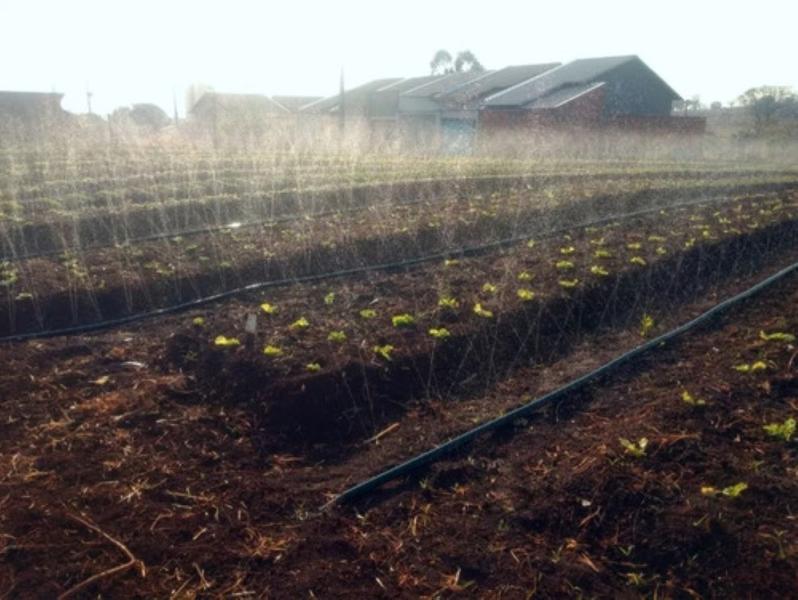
left=322, top=262, right=798, bottom=510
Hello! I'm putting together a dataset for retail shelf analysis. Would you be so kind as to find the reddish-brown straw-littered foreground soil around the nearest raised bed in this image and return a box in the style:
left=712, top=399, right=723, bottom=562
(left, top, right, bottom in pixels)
left=0, top=197, right=798, bottom=598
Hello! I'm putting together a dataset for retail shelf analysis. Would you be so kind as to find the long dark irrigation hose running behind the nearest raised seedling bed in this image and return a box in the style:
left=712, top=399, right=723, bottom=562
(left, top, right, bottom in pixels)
left=0, top=190, right=792, bottom=343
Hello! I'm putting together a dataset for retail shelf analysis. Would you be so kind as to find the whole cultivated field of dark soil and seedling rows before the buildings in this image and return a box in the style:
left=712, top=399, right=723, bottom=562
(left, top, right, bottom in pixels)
left=0, top=148, right=798, bottom=598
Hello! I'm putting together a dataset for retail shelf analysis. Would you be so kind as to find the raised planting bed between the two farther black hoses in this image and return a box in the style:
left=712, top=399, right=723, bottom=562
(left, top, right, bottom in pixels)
left=0, top=177, right=792, bottom=335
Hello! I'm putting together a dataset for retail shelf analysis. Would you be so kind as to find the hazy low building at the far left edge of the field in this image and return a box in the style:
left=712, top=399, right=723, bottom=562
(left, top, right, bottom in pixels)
left=0, top=91, right=68, bottom=137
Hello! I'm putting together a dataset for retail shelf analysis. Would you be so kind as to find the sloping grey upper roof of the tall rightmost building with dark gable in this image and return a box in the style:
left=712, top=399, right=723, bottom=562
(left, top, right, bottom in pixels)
left=485, top=56, right=640, bottom=106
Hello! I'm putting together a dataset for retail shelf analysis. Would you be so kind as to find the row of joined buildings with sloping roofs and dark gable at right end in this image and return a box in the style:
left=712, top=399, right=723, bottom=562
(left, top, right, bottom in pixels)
left=302, top=56, right=704, bottom=151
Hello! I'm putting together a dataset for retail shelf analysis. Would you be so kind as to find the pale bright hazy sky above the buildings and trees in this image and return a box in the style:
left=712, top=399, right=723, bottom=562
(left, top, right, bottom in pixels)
left=0, top=0, right=798, bottom=115
